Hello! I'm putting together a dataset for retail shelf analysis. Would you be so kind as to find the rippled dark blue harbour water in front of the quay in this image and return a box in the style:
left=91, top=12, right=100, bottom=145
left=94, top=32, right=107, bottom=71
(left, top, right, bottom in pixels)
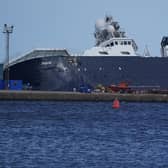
left=0, top=101, right=168, bottom=168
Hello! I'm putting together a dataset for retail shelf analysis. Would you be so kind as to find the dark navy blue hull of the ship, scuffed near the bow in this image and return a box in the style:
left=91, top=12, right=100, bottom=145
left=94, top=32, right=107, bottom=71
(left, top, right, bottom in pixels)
left=6, top=56, right=168, bottom=91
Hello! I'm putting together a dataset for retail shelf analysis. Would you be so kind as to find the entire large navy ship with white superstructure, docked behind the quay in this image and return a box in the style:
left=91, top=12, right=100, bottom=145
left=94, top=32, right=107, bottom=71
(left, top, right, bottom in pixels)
left=4, top=16, right=168, bottom=91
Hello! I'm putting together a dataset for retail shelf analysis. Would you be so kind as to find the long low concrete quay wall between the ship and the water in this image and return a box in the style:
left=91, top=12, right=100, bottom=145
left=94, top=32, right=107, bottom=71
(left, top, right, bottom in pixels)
left=0, top=90, right=168, bottom=102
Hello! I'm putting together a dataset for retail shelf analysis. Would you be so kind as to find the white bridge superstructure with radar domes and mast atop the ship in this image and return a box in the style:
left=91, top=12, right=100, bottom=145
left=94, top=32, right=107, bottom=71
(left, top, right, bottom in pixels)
left=83, top=16, right=138, bottom=56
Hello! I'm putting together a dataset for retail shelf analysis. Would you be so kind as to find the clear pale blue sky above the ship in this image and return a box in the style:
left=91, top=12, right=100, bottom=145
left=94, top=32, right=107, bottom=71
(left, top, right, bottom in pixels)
left=0, top=0, right=168, bottom=61
